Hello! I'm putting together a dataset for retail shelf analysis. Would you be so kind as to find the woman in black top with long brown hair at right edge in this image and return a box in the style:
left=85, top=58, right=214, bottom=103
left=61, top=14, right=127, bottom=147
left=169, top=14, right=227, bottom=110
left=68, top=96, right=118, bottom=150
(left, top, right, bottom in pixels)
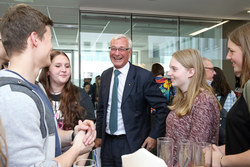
left=213, top=23, right=250, bottom=167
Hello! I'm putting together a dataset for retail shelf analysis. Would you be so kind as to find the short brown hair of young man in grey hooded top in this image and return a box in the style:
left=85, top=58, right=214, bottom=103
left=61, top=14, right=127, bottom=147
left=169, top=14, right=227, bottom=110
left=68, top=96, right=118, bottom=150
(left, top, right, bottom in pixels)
left=0, top=4, right=53, bottom=56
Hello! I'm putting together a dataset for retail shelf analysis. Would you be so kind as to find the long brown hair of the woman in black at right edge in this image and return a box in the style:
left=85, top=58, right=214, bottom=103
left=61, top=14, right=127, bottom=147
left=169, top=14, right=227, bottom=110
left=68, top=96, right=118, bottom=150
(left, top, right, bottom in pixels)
left=228, top=22, right=250, bottom=87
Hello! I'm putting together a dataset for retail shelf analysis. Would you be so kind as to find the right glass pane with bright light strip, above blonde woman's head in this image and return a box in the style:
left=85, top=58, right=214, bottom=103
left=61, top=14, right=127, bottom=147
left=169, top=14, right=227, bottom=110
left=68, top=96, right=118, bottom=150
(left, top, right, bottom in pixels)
left=180, top=19, right=223, bottom=67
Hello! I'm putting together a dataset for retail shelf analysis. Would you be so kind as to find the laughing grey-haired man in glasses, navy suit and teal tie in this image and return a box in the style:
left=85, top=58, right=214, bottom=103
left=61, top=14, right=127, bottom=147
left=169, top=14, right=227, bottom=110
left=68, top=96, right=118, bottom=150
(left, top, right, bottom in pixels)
left=95, top=34, right=169, bottom=167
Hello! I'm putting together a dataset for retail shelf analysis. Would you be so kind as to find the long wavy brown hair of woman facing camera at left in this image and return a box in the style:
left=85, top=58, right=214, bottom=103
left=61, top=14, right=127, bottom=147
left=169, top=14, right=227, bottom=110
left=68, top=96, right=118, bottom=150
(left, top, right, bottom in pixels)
left=39, top=51, right=86, bottom=129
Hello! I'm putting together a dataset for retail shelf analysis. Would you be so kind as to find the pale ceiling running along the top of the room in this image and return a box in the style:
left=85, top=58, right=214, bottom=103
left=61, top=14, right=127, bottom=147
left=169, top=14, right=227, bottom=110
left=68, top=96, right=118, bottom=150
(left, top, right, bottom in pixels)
left=0, top=0, right=250, bottom=49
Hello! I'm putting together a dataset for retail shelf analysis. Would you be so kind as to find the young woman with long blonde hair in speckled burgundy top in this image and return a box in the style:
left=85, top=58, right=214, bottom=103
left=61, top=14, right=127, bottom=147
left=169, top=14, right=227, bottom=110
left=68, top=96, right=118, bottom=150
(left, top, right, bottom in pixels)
left=166, top=49, right=220, bottom=165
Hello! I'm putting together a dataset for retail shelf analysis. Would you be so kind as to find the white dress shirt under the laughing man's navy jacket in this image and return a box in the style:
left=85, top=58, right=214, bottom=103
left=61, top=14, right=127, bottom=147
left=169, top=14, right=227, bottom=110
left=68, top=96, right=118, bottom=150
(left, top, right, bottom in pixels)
left=106, top=62, right=130, bottom=135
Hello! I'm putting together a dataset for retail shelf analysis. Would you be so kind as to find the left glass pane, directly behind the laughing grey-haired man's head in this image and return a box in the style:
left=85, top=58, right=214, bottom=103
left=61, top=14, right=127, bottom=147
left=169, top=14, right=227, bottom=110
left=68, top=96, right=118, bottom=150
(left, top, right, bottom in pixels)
left=80, top=13, right=131, bottom=85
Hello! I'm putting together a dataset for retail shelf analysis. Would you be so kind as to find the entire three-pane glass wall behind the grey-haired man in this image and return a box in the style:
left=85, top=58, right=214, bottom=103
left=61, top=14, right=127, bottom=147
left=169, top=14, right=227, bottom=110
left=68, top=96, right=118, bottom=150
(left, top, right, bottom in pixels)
left=77, top=11, right=223, bottom=85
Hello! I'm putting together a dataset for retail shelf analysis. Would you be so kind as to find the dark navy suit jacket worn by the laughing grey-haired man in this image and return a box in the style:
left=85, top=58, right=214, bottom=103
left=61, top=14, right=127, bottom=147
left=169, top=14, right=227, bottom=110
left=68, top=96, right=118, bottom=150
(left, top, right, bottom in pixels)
left=96, top=64, right=169, bottom=152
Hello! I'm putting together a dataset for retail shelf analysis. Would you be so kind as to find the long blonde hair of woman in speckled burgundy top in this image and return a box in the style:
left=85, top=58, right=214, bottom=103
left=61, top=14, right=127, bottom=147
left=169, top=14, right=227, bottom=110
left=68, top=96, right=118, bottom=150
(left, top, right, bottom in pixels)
left=169, top=49, right=213, bottom=117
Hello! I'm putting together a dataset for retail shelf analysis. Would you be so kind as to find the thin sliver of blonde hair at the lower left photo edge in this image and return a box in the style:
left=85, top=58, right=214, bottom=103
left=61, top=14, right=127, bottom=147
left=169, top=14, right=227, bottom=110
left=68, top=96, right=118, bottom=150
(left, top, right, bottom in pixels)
left=0, top=119, right=8, bottom=167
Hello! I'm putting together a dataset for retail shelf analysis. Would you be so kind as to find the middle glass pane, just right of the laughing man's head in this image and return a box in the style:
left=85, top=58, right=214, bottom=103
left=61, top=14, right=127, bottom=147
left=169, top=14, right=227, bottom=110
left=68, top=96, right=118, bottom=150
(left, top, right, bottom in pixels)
left=132, top=16, right=178, bottom=71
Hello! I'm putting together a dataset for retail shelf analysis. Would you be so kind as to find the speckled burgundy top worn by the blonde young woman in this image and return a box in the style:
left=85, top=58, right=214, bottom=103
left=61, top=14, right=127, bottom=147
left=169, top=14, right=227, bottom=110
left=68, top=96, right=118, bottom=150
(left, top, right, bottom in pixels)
left=166, top=90, right=220, bottom=164
